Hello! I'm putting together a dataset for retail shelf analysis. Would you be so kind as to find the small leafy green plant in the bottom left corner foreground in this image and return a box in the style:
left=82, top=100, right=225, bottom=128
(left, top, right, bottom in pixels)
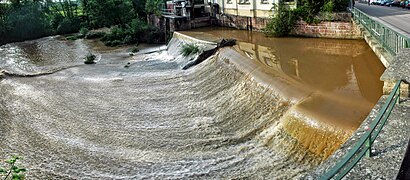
left=0, top=156, right=27, bottom=180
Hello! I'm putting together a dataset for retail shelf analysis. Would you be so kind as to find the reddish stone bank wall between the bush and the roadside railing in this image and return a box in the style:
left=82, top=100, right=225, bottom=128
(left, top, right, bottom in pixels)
left=291, top=21, right=363, bottom=39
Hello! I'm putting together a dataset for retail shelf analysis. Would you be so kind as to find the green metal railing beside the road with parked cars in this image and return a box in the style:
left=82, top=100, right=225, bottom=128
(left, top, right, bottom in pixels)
left=351, top=8, right=410, bottom=56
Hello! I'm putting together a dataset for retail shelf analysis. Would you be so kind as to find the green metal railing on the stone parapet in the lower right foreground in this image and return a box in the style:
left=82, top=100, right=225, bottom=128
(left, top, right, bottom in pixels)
left=320, top=80, right=401, bottom=180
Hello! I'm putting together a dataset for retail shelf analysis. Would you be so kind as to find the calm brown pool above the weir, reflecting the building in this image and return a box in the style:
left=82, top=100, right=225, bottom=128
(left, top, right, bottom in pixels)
left=183, top=28, right=385, bottom=130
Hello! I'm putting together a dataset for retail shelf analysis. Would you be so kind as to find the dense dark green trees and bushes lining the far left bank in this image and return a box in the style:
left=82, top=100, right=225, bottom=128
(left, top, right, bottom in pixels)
left=0, top=0, right=155, bottom=44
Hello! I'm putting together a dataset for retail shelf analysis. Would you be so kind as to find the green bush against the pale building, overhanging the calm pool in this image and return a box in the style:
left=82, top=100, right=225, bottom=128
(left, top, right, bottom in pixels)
left=265, top=2, right=297, bottom=37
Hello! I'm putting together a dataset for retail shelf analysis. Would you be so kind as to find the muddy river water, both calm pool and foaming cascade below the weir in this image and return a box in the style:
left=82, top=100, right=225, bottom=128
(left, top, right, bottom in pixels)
left=0, top=29, right=384, bottom=179
